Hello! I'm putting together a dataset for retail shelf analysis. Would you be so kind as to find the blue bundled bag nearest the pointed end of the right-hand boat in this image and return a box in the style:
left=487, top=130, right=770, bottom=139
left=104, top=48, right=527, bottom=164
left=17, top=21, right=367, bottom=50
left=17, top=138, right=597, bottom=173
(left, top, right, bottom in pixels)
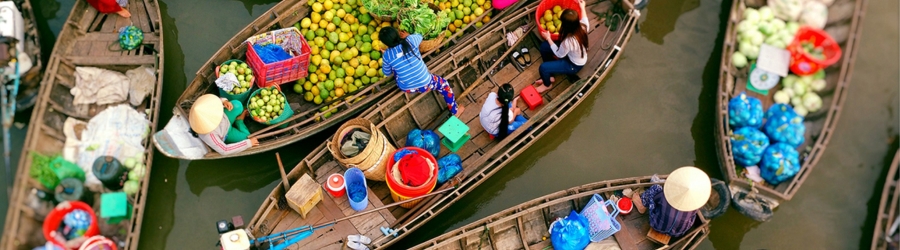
left=760, top=143, right=800, bottom=185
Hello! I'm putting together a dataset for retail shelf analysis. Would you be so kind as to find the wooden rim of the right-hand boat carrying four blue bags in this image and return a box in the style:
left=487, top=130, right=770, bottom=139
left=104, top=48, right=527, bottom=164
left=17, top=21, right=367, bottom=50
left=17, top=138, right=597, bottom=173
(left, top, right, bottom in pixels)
left=714, top=0, right=867, bottom=201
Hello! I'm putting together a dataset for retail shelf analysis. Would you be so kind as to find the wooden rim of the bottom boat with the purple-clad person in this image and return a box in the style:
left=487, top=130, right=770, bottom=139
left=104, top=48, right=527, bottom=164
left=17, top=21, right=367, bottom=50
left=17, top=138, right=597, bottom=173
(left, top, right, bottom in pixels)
left=410, top=175, right=710, bottom=249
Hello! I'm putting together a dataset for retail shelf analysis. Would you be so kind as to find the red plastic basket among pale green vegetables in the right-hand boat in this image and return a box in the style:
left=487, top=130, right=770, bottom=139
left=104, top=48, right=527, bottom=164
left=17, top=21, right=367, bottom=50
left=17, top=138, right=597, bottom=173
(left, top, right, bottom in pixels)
left=788, top=26, right=841, bottom=76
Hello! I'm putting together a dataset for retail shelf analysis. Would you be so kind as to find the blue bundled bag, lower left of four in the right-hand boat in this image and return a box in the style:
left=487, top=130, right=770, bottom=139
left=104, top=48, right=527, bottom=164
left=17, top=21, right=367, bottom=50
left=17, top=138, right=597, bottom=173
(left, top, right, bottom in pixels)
left=731, top=127, right=769, bottom=166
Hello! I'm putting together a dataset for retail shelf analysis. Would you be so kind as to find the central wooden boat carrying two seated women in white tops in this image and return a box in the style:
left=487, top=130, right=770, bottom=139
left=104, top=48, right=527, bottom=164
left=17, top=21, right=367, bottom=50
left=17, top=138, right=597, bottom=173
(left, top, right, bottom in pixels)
left=247, top=0, right=640, bottom=249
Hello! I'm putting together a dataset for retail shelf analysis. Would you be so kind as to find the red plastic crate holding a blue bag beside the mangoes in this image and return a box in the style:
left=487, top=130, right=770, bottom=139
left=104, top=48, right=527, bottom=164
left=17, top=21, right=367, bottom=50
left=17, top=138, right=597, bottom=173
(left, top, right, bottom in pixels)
left=245, top=27, right=310, bottom=88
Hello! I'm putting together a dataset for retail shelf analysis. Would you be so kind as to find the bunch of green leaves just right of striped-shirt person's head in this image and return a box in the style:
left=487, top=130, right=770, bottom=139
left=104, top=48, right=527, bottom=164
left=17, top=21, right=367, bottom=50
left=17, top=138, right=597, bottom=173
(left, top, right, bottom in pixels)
left=397, top=4, right=450, bottom=40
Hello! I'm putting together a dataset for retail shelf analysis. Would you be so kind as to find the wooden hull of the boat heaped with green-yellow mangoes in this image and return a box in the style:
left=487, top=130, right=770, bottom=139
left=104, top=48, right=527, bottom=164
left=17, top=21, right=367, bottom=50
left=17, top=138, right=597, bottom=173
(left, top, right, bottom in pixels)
left=153, top=0, right=521, bottom=160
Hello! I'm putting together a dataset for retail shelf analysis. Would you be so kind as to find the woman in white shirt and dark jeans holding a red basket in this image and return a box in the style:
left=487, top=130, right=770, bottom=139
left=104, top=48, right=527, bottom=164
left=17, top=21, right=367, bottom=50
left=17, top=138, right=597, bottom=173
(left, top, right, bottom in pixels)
left=535, top=0, right=590, bottom=93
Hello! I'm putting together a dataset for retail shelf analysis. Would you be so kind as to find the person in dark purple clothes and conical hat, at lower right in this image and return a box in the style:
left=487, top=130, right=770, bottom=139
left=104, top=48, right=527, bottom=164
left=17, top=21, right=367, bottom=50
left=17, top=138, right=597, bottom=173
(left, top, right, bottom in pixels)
left=641, top=167, right=712, bottom=237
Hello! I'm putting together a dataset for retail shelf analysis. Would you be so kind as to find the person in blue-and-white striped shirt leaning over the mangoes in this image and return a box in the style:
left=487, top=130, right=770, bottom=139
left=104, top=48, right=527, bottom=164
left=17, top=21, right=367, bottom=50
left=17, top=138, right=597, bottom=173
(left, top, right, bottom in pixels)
left=378, top=27, right=464, bottom=115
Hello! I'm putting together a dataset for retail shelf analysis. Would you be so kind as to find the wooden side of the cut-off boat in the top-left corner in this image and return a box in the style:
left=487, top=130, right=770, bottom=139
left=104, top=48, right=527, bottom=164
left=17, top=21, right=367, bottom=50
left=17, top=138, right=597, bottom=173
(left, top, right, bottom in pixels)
left=0, top=0, right=44, bottom=112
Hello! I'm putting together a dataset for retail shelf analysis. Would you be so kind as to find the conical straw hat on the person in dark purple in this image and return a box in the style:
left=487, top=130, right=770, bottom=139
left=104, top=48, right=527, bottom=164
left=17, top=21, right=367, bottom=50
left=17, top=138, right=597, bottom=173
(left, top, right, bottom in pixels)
left=663, top=167, right=712, bottom=211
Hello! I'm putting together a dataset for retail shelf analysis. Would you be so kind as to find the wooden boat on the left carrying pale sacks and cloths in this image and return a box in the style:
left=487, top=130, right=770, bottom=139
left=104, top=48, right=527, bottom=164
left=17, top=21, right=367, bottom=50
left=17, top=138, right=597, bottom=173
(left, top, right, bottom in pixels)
left=0, top=0, right=165, bottom=249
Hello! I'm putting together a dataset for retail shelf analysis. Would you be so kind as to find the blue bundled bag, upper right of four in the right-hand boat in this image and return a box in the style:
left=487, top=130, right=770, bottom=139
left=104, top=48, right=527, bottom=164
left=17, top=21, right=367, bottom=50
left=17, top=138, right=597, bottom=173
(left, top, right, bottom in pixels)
left=763, top=104, right=806, bottom=148
